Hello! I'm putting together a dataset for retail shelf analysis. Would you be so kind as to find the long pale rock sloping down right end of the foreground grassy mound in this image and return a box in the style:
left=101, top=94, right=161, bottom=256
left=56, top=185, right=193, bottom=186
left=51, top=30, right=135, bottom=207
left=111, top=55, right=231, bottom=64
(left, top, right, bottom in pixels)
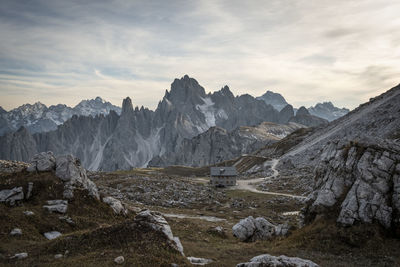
left=134, top=210, right=184, bottom=256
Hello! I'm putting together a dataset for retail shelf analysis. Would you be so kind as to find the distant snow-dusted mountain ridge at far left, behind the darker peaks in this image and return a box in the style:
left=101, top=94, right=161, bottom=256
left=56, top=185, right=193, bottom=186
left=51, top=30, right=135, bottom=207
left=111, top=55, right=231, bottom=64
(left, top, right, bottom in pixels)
left=0, top=97, right=121, bottom=135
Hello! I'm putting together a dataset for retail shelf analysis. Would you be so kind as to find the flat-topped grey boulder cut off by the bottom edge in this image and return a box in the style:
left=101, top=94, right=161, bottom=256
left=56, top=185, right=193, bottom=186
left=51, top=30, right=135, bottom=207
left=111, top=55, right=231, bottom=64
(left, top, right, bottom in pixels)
left=236, top=254, right=319, bottom=267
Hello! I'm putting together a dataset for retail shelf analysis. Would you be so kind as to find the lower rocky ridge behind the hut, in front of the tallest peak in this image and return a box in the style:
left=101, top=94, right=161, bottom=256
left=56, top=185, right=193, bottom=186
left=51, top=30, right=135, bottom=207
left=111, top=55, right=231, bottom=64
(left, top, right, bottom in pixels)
left=149, top=122, right=305, bottom=166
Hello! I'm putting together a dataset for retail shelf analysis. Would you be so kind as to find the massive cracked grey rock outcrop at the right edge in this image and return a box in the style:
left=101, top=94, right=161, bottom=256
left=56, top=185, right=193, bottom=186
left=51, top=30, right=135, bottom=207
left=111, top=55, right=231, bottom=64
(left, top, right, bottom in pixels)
left=303, top=139, right=400, bottom=228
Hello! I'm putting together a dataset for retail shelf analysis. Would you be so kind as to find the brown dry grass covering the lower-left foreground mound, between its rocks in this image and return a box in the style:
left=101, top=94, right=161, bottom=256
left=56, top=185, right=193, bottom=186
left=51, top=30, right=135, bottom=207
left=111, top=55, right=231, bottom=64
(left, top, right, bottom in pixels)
left=0, top=172, right=187, bottom=266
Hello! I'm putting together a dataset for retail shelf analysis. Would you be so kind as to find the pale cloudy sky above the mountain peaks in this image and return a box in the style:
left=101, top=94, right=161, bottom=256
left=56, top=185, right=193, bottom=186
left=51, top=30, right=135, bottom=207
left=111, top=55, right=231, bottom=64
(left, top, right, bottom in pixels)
left=0, top=0, right=400, bottom=110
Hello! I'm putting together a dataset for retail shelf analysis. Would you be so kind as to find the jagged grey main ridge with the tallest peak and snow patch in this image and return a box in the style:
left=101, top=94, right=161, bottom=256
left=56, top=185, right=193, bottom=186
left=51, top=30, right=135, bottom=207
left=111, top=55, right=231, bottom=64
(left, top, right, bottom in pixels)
left=0, top=75, right=320, bottom=171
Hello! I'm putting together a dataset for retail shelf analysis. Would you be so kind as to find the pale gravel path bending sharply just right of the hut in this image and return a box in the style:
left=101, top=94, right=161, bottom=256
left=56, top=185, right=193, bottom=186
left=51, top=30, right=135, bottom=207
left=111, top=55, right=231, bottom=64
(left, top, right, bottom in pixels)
left=232, top=159, right=306, bottom=199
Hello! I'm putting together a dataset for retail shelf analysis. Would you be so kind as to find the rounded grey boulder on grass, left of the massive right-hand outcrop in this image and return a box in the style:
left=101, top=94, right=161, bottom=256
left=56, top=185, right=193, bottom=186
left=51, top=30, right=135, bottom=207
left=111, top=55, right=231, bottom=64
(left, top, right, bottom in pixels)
left=232, top=216, right=288, bottom=241
